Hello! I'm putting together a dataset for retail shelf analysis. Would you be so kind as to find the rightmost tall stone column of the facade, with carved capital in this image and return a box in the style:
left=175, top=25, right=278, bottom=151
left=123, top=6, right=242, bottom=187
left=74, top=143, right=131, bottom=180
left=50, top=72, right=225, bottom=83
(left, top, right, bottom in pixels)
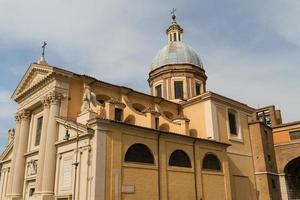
left=42, top=92, right=62, bottom=199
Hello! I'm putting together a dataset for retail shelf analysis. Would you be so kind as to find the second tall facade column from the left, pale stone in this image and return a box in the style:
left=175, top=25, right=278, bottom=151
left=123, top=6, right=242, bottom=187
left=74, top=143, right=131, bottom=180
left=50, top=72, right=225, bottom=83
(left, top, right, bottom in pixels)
left=11, top=110, right=30, bottom=199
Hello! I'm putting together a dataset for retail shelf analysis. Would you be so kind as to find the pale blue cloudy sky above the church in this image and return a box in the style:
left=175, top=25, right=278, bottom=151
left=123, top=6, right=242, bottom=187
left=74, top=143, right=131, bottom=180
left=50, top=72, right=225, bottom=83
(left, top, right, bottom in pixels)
left=0, top=0, right=300, bottom=149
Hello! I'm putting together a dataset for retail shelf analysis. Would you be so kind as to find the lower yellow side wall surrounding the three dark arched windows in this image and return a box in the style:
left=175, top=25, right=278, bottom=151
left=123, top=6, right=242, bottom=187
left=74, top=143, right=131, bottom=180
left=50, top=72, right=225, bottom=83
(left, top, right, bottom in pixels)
left=101, top=125, right=231, bottom=200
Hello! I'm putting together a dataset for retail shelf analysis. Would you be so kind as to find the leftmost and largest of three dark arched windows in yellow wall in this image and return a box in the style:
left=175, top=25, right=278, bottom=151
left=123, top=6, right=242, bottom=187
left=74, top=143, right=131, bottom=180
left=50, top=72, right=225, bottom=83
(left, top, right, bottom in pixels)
left=124, top=143, right=154, bottom=164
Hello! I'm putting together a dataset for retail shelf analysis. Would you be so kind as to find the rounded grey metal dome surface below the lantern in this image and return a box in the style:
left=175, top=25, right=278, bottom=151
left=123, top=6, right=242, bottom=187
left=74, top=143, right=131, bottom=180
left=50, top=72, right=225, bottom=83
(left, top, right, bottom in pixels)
left=151, top=42, right=203, bottom=70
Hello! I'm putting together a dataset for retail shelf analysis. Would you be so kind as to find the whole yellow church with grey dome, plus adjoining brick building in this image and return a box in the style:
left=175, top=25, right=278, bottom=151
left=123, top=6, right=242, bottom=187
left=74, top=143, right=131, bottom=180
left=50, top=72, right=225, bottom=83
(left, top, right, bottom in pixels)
left=0, top=15, right=300, bottom=200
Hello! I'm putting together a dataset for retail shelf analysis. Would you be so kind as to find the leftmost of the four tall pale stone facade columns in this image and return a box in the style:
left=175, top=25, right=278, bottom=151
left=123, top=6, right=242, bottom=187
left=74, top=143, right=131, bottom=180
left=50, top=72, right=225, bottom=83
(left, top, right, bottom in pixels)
left=7, top=113, right=21, bottom=195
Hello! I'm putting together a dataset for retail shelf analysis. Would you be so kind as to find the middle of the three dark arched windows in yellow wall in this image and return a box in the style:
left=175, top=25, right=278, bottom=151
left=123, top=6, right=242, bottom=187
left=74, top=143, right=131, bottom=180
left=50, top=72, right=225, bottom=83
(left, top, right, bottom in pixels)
left=169, top=150, right=192, bottom=168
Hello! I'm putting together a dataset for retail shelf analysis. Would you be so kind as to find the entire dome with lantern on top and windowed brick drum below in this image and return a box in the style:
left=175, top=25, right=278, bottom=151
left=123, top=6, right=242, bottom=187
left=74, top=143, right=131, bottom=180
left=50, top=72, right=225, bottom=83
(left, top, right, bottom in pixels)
left=148, top=18, right=207, bottom=102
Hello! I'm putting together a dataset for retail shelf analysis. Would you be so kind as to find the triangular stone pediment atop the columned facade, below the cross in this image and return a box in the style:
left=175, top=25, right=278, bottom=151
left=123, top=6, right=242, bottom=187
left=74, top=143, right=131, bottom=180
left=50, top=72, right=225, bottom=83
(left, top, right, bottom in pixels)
left=12, top=64, right=53, bottom=99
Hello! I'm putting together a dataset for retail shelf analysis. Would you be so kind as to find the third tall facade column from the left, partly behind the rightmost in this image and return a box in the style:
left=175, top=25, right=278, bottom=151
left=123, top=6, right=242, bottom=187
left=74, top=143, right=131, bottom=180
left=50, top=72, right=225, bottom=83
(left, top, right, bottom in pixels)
left=35, top=96, right=50, bottom=195
